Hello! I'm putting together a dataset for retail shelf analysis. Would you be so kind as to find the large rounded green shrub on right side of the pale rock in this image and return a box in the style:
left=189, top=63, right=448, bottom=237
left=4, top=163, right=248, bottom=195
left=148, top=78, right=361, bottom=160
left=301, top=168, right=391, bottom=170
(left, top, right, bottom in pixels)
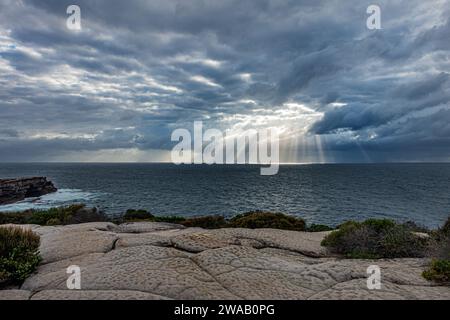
left=322, top=219, right=429, bottom=259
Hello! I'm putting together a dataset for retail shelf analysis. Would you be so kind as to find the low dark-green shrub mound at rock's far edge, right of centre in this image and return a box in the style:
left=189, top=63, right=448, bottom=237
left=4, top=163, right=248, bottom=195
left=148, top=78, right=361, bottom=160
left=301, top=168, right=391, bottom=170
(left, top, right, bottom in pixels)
left=228, top=211, right=306, bottom=231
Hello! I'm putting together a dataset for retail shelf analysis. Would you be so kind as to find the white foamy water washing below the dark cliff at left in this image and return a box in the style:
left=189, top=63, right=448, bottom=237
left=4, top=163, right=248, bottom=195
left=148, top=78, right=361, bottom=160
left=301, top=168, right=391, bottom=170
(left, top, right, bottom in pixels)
left=0, top=189, right=98, bottom=212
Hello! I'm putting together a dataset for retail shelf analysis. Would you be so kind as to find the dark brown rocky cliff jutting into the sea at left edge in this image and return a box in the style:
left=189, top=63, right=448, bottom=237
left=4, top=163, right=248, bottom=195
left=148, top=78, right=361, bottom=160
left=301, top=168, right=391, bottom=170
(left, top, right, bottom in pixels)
left=0, top=177, right=57, bottom=205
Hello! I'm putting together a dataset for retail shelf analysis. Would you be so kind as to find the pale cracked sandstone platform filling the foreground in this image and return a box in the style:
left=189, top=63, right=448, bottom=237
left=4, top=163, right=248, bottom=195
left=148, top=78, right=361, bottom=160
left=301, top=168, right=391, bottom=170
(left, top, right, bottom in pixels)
left=0, top=222, right=450, bottom=300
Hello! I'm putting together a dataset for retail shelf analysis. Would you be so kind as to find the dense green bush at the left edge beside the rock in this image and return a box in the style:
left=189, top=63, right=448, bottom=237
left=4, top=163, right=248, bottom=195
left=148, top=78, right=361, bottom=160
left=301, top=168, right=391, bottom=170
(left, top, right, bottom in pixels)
left=0, top=227, right=41, bottom=284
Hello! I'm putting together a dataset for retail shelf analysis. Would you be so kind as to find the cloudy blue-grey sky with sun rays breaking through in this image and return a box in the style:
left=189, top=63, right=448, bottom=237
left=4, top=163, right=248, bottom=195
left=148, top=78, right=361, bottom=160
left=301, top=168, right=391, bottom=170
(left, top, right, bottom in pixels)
left=0, top=0, right=450, bottom=163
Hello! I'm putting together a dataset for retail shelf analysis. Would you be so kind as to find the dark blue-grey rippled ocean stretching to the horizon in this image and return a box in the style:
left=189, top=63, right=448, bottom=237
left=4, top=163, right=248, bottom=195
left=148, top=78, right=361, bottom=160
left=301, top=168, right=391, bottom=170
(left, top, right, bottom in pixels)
left=0, top=163, right=450, bottom=228
